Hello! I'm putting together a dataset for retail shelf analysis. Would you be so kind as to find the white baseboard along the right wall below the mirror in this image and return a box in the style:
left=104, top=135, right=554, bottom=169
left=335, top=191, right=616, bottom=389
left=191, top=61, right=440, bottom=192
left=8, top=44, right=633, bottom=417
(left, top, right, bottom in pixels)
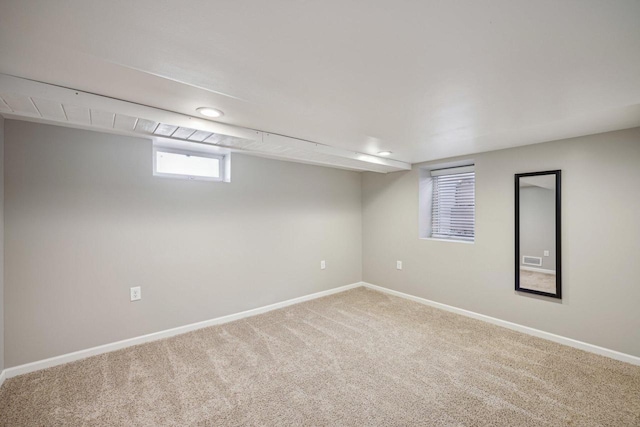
left=362, top=282, right=640, bottom=366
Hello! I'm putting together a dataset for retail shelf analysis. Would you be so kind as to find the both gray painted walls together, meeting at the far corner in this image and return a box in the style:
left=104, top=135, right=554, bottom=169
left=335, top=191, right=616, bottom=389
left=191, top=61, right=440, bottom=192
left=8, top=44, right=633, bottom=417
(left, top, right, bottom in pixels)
left=5, top=120, right=640, bottom=367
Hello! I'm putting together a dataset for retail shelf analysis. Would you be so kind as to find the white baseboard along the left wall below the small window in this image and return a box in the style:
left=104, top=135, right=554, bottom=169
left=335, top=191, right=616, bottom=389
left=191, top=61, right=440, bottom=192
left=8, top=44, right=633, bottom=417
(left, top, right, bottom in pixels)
left=0, top=282, right=362, bottom=384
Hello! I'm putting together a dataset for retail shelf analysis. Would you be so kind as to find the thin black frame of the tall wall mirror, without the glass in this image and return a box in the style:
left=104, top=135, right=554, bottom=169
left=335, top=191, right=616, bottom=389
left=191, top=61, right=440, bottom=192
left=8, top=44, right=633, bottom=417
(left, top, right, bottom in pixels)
left=515, top=170, right=562, bottom=299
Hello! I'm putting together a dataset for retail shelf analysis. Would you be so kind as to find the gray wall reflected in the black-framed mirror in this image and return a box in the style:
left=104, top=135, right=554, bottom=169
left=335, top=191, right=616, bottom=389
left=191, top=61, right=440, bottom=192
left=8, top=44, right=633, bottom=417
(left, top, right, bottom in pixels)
left=520, top=187, right=556, bottom=270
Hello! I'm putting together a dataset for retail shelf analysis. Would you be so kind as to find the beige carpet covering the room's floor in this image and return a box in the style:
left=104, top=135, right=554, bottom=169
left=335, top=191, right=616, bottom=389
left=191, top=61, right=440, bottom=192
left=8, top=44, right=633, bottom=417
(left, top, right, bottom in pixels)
left=0, top=288, right=640, bottom=427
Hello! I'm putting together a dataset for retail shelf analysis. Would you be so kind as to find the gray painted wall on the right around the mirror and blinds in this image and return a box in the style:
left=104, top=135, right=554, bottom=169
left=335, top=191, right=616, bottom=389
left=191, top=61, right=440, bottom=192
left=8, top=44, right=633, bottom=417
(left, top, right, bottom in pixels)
left=362, top=128, right=640, bottom=356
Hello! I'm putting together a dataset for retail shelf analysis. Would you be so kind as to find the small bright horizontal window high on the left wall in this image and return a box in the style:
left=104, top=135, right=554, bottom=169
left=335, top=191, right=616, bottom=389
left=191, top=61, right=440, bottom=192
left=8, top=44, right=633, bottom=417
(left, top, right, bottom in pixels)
left=153, top=147, right=225, bottom=181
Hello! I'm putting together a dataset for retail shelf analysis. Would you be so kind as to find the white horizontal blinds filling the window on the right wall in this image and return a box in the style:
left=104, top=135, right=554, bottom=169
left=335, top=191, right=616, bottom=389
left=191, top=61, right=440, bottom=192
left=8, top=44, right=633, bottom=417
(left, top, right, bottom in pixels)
left=431, top=166, right=476, bottom=242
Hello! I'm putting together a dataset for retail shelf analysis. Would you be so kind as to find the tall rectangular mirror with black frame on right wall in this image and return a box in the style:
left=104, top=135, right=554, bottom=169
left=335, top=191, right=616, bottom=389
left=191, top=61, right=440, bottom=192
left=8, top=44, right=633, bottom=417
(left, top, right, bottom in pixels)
left=515, top=170, right=562, bottom=298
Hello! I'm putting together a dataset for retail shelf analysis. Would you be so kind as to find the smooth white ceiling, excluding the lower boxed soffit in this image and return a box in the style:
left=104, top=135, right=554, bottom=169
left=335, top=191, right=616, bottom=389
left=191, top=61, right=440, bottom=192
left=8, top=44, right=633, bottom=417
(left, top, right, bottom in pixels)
left=0, top=0, right=640, bottom=163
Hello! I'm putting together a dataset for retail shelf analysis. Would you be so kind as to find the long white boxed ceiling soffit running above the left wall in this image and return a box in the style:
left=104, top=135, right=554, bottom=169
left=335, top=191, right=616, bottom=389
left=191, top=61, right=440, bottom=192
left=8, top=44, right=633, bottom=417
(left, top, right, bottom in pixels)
left=0, top=74, right=411, bottom=173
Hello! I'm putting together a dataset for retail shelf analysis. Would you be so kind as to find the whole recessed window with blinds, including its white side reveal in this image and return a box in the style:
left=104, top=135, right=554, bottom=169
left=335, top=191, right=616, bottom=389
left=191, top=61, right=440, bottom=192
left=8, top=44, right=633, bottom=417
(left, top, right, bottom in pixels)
left=420, top=165, right=476, bottom=242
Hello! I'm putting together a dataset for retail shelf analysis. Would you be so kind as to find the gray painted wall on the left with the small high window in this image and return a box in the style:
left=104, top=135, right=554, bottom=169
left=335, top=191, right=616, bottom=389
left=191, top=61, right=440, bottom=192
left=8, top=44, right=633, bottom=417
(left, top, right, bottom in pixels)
left=5, top=120, right=362, bottom=367
